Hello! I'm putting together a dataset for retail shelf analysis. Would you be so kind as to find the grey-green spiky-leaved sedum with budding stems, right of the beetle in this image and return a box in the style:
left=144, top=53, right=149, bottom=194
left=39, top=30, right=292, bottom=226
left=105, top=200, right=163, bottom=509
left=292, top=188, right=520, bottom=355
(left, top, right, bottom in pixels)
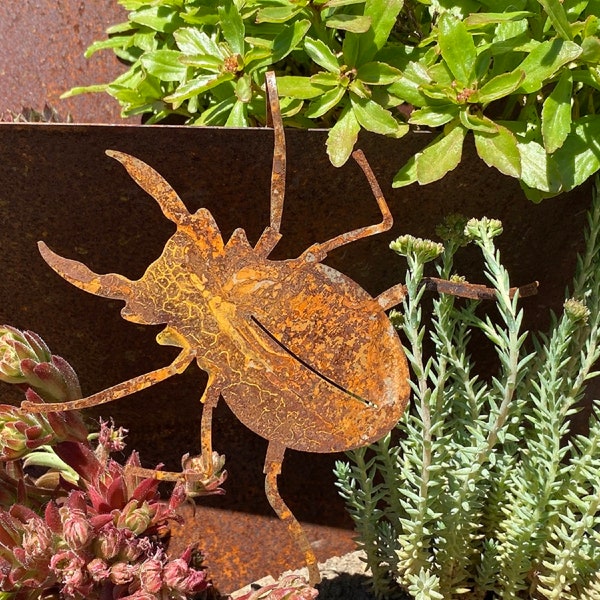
left=336, top=179, right=600, bottom=600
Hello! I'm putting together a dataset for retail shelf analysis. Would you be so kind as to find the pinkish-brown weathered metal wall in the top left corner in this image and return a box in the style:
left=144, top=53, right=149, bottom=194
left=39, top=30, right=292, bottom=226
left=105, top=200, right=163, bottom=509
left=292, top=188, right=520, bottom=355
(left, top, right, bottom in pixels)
left=0, top=0, right=129, bottom=123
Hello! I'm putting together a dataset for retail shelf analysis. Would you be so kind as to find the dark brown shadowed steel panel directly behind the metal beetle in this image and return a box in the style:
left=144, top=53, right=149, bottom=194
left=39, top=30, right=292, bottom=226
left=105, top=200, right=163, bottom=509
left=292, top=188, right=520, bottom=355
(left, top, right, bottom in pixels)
left=0, top=124, right=590, bottom=584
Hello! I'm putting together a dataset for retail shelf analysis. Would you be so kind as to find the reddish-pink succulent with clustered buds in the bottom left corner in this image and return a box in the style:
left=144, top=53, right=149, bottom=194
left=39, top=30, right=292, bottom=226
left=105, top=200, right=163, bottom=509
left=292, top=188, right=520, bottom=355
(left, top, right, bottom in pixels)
left=0, top=326, right=214, bottom=600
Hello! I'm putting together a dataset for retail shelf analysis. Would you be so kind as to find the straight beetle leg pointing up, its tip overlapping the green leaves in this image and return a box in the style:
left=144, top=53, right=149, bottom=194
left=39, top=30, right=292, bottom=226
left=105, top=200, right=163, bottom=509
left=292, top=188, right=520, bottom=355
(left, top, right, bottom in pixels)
left=254, top=71, right=286, bottom=257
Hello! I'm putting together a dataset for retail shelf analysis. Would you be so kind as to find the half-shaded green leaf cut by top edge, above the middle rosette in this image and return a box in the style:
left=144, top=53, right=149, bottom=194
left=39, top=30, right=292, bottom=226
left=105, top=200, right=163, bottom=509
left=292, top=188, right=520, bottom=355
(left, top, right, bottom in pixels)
left=342, top=0, right=404, bottom=67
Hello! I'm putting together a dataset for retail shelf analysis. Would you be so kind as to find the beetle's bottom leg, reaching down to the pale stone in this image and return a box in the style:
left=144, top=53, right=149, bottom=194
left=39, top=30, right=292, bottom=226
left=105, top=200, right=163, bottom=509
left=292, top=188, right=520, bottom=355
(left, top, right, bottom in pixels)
left=264, top=441, right=321, bottom=586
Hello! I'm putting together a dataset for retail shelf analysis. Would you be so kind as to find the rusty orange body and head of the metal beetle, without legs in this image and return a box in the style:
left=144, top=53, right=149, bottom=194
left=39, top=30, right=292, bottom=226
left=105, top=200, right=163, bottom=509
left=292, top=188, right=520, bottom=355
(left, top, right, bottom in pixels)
left=43, top=199, right=408, bottom=452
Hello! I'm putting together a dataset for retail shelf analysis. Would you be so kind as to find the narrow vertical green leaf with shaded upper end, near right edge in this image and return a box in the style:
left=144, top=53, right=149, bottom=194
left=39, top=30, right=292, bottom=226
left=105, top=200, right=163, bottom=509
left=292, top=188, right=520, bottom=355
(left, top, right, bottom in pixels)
left=542, top=70, right=573, bottom=154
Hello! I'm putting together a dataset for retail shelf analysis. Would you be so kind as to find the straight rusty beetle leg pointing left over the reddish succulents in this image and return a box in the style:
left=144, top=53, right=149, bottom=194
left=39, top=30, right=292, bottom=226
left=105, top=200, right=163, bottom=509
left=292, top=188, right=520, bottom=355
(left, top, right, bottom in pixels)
left=21, top=348, right=194, bottom=413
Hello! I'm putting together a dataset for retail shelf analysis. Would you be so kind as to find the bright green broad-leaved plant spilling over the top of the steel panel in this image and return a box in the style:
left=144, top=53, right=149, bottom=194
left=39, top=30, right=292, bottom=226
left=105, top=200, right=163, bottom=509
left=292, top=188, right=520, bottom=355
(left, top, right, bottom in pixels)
left=66, top=0, right=600, bottom=200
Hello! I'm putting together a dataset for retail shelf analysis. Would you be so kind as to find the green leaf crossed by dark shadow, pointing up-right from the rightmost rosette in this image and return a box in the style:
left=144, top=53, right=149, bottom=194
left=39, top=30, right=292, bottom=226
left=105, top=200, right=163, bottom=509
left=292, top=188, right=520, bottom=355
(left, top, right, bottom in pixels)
left=517, top=39, right=581, bottom=94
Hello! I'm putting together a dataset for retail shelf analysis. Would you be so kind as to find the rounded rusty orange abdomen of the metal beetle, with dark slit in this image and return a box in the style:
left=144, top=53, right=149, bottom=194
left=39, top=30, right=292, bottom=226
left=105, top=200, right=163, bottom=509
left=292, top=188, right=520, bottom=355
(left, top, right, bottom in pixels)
left=222, top=261, right=409, bottom=452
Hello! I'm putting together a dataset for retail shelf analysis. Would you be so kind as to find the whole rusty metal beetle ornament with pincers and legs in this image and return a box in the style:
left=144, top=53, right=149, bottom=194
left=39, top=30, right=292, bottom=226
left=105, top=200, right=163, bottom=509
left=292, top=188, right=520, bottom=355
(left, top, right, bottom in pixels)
left=22, top=73, right=540, bottom=585
